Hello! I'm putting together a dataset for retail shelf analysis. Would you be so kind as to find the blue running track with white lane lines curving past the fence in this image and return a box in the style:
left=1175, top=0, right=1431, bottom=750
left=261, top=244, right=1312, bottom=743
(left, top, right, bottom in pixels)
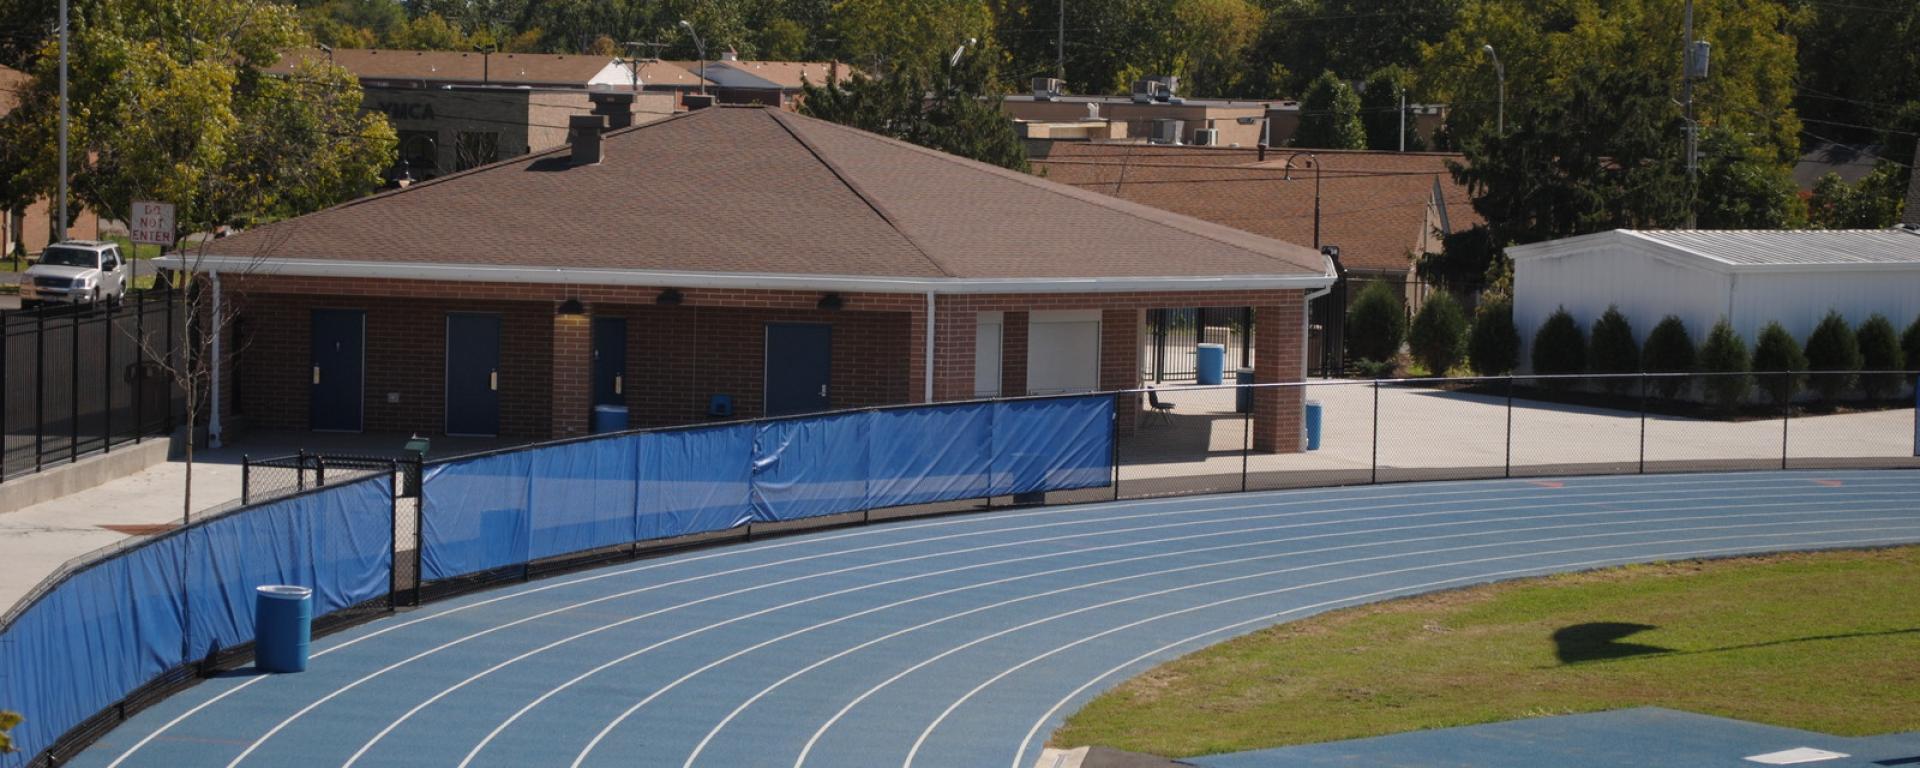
left=73, top=470, right=1920, bottom=768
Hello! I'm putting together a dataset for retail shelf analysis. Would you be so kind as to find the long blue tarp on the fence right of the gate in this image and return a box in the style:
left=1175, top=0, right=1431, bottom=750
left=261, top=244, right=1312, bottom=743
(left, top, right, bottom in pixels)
left=420, top=396, right=1114, bottom=582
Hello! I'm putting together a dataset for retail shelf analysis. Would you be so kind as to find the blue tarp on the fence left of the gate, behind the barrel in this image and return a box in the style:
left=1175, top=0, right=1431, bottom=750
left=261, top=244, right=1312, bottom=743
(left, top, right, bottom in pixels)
left=0, top=474, right=394, bottom=768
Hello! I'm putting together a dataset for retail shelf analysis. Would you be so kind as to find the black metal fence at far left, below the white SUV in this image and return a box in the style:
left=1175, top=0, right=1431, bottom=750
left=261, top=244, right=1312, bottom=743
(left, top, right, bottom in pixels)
left=0, top=292, right=182, bottom=478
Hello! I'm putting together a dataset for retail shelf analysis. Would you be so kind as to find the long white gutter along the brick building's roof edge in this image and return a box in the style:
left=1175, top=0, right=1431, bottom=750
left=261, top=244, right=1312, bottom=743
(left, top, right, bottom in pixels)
left=154, top=255, right=1334, bottom=294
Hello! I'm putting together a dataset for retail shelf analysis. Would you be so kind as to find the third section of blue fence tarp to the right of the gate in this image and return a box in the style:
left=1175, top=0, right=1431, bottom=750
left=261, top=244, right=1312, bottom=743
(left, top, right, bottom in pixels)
left=634, top=424, right=756, bottom=541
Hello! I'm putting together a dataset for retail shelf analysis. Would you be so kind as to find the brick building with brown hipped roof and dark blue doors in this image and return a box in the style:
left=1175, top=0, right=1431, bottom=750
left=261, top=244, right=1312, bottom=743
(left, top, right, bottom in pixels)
left=175, top=108, right=1332, bottom=451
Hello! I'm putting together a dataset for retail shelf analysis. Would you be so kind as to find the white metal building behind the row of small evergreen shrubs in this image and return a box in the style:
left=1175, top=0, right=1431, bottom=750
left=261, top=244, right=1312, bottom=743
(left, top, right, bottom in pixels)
left=1507, top=227, right=1920, bottom=367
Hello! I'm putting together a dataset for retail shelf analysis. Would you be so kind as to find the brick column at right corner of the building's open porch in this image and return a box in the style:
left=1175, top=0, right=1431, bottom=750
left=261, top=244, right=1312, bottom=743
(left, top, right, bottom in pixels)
left=1254, top=290, right=1306, bottom=453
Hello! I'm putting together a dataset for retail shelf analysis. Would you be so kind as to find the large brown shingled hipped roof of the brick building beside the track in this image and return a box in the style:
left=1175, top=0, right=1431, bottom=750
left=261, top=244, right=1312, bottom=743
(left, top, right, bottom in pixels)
left=202, top=108, right=1327, bottom=288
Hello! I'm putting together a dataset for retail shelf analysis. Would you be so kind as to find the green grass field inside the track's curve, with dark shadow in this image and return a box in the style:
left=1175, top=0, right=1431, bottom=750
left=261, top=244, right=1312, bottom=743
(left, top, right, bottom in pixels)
left=1052, top=547, right=1920, bottom=756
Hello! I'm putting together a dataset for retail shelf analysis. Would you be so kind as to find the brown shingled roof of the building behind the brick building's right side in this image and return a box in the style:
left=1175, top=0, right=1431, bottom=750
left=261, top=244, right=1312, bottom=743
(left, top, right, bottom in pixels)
left=1033, top=142, right=1480, bottom=273
